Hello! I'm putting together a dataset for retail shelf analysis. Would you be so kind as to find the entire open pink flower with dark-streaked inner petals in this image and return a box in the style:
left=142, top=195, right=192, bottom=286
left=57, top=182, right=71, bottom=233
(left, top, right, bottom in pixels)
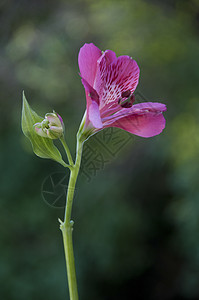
left=78, top=43, right=166, bottom=137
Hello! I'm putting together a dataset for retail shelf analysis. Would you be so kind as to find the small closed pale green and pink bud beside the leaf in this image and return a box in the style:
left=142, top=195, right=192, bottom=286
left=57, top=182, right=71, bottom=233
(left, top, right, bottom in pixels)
left=34, top=111, right=64, bottom=140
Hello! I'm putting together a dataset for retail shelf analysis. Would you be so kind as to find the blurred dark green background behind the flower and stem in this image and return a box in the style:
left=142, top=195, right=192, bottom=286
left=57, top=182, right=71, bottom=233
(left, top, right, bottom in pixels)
left=0, top=0, right=199, bottom=300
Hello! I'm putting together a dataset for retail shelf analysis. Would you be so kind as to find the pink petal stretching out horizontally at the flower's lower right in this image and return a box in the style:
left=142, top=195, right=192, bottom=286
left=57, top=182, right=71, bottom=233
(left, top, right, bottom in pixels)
left=103, top=102, right=166, bottom=138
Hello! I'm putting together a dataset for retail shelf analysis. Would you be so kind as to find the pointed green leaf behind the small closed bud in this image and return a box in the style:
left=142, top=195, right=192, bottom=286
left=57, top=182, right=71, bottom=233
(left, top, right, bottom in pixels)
left=21, top=92, right=67, bottom=167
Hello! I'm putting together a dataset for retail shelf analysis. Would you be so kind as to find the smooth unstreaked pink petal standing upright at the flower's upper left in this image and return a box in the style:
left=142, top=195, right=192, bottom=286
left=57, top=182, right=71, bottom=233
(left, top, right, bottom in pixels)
left=78, top=43, right=102, bottom=86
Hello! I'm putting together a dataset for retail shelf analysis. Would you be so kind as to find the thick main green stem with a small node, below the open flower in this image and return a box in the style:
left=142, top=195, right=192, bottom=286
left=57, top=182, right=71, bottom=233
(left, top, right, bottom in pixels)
left=59, top=136, right=84, bottom=300
